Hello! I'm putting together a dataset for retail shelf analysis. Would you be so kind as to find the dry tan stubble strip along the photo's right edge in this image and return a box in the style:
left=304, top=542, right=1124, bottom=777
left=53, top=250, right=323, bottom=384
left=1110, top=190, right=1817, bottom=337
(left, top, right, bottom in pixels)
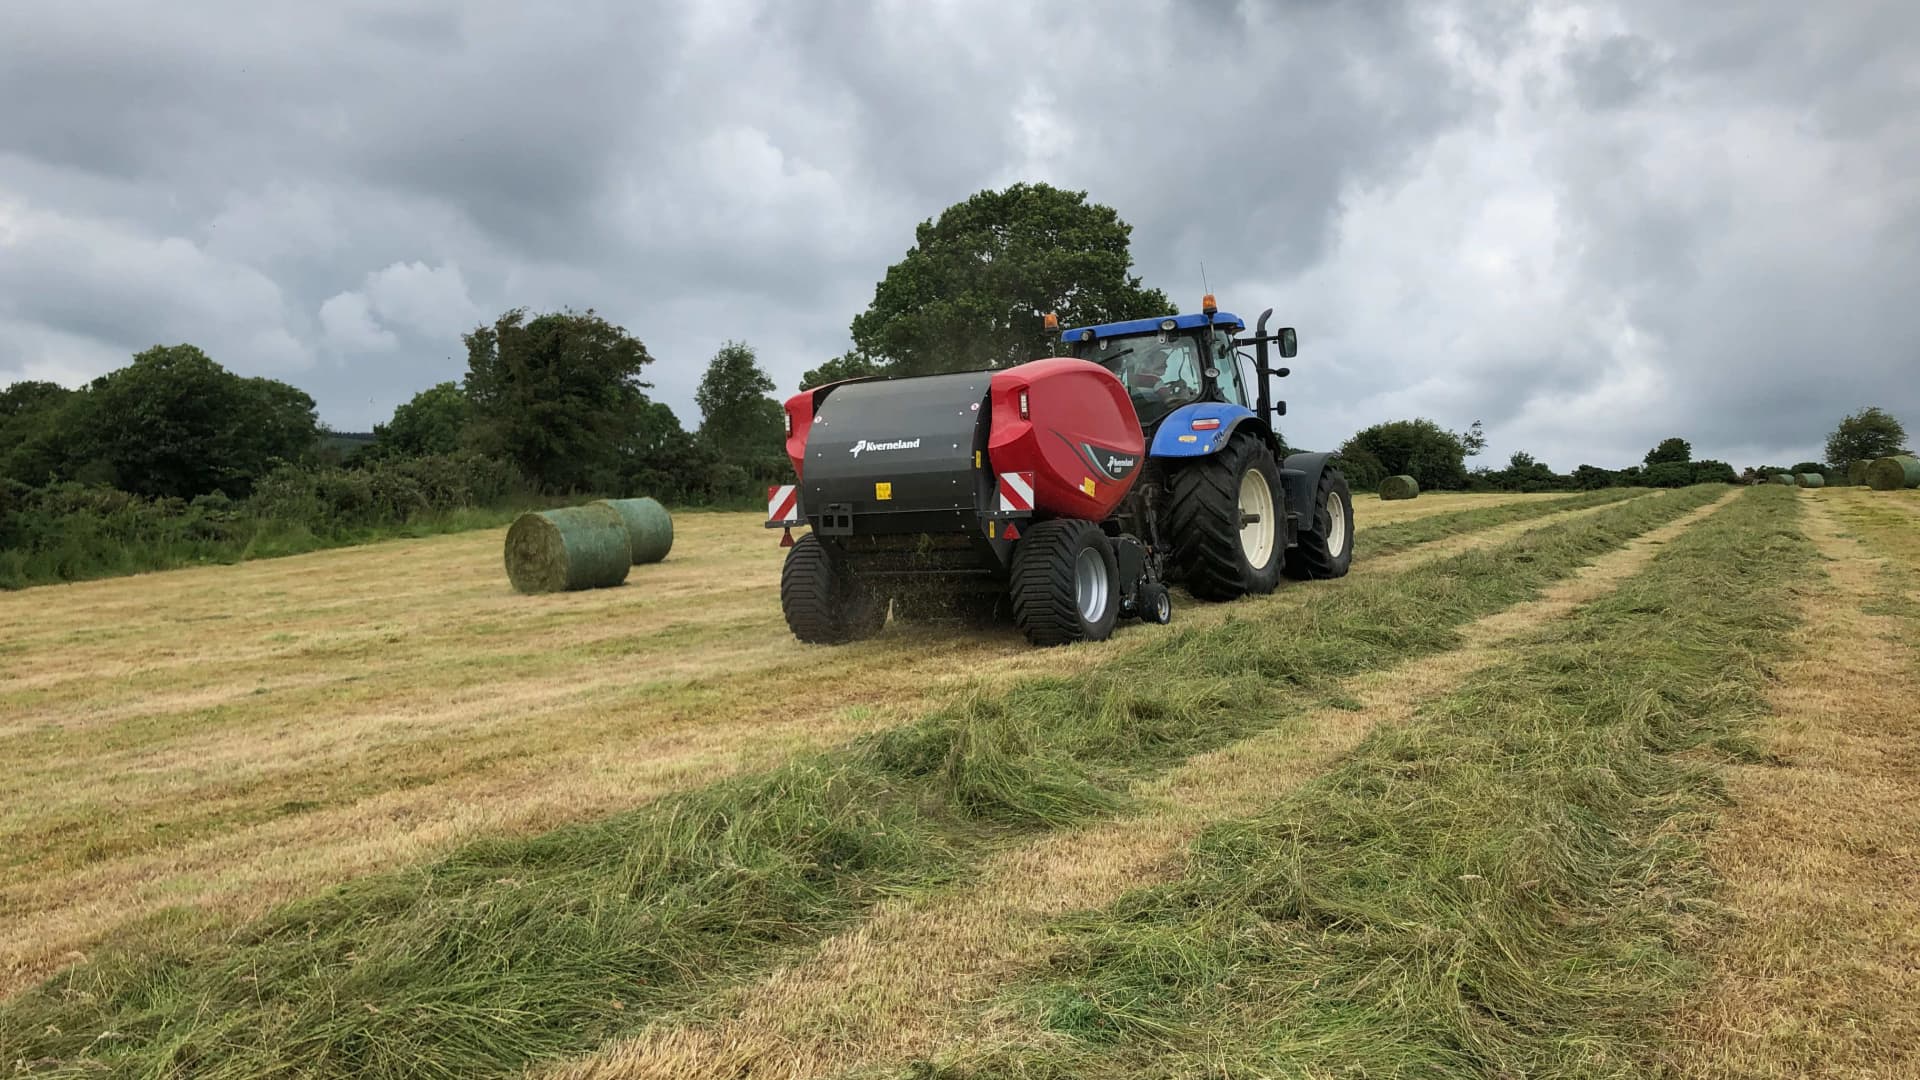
left=1668, top=488, right=1920, bottom=1080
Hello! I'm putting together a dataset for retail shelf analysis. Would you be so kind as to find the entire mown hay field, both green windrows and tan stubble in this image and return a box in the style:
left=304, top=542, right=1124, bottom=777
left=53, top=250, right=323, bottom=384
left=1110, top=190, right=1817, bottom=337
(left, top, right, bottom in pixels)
left=0, top=488, right=1920, bottom=1076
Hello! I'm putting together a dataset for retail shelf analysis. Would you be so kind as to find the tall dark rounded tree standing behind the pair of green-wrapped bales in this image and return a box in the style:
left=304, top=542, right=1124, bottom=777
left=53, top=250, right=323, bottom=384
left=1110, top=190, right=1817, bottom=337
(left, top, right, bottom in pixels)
left=463, top=307, right=653, bottom=490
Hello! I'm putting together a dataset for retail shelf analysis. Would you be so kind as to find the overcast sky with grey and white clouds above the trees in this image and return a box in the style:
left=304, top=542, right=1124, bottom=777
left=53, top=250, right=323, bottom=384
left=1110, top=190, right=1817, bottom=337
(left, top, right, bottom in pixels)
left=0, top=0, right=1920, bottom=471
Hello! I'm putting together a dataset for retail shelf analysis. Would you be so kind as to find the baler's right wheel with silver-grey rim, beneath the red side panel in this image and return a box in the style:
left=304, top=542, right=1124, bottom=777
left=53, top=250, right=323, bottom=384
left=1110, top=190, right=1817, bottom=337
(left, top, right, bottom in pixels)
left=1010, top=521, right=1119, bottom=646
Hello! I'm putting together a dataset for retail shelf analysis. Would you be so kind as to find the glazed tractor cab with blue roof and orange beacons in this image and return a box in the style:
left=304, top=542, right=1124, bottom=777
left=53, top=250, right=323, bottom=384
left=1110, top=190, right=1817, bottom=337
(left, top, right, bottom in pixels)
left=1060, top=311, right=1254, bottom=432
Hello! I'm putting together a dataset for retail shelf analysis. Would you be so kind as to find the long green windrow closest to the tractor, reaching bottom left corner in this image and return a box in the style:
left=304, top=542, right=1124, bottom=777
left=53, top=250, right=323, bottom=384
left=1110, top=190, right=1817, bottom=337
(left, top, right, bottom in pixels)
left=0, top=488, right=1724, bottom=1076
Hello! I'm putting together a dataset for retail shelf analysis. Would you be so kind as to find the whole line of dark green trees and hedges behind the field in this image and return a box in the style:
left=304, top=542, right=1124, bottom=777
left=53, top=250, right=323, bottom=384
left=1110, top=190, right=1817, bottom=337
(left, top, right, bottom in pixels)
left=0, top=184, right=1905, bottom=586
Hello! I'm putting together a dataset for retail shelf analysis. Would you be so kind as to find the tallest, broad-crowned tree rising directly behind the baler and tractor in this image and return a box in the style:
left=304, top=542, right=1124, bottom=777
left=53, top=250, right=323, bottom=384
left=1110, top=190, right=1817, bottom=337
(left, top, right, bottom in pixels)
left=852, top=184, right=1173, bottom=375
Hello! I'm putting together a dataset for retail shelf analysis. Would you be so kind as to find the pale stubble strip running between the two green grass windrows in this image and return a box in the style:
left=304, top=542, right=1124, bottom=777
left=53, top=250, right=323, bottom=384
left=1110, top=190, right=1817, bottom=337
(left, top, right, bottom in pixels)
left=540, top=492, right=1734, bottom=1080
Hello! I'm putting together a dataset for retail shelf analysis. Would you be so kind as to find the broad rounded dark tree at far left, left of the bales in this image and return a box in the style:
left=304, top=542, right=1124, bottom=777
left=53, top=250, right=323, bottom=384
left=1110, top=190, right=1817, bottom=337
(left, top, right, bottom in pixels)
left=63, top=344, right=319, bottom=498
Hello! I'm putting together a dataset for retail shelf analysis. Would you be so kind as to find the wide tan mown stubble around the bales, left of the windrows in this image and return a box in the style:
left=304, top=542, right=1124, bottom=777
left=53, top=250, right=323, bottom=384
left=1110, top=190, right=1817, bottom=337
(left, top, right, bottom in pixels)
left=0, top=494, right=1559, bottom=992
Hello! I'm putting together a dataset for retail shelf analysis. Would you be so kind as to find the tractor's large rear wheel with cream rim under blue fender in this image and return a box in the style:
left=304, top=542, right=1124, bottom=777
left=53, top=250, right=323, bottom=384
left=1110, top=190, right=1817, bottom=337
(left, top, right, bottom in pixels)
left=1169, top=432, right=1286, bottom=600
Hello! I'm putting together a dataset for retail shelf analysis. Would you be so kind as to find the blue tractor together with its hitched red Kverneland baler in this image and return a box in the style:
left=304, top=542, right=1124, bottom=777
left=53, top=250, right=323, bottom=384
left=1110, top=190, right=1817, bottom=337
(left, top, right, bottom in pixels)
left=768, top=296, right=1354, bottom=646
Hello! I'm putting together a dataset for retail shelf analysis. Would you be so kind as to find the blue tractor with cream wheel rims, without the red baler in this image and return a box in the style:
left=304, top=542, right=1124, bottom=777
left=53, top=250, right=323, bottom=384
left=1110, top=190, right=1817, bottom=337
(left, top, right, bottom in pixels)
left=1060, top=294, right=1354, bottom=600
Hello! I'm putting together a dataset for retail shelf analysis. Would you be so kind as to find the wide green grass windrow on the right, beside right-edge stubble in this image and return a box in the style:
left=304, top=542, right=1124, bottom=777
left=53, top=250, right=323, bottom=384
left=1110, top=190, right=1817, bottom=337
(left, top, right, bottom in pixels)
left=916, top=488, right=1812, bottom=1078
